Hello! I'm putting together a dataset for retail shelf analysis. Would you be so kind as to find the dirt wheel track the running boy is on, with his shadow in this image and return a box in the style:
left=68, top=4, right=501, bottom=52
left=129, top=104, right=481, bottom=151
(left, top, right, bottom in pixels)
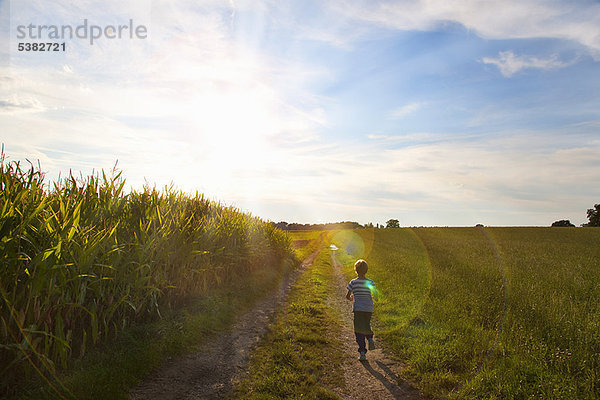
left=330, top=256, right=425, bottom=400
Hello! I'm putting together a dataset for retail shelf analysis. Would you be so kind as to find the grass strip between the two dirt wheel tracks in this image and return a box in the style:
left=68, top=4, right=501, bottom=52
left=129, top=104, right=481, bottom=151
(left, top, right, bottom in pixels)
left=234, top=238, right=344, bottom=399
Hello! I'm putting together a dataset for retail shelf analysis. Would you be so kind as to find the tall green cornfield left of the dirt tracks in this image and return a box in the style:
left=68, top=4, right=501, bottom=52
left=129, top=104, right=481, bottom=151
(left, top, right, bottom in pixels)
left=0, top=158, right=291, bottom=394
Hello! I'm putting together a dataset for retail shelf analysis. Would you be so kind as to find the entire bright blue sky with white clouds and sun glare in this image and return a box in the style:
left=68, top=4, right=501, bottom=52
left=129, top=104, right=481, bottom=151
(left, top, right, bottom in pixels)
left=0, top=0, right=600, bottom=226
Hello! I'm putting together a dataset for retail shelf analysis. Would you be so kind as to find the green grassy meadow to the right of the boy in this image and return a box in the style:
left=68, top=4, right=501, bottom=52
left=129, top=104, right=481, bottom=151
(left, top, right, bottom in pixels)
left=334, top=228, right=600, bottom=399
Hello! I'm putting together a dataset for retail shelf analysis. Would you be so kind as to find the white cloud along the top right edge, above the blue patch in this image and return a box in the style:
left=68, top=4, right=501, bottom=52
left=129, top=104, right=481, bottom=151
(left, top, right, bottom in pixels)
left=335, top=0, right=600, bottom=59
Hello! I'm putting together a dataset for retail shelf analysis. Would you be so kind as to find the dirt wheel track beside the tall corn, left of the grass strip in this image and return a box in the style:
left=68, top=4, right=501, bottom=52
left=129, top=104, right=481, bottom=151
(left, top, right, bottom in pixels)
left=129, top=249, right=320, bottom=400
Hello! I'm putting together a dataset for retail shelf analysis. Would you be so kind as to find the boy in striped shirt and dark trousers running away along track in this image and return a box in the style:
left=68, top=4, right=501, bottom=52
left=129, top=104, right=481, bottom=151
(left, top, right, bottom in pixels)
left=346, top=260, right=377, bottom=361
